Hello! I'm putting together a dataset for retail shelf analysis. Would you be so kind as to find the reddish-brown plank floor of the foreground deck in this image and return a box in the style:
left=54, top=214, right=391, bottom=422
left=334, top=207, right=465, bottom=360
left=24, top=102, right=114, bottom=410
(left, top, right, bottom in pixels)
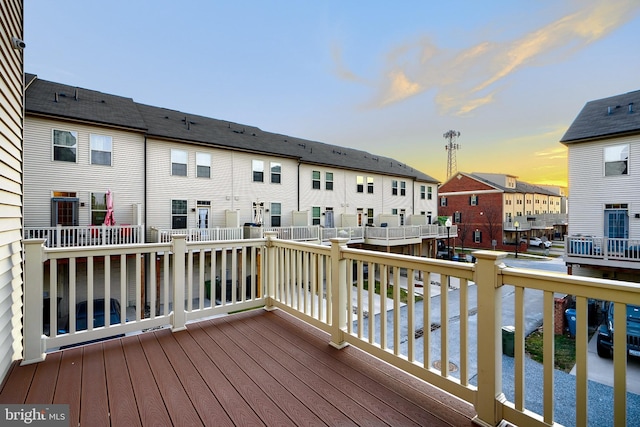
left=0, top=310, right=474, bottom=427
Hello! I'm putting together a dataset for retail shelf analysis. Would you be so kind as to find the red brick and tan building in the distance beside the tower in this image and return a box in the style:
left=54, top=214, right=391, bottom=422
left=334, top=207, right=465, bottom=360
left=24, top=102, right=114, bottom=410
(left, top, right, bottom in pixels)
left=438, top=172, right=566, bottom=250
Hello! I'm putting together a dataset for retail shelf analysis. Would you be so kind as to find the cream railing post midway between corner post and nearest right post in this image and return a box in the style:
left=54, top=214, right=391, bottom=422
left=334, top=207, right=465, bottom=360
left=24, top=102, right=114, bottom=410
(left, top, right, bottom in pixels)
left=329, top=237, right=351, bottom=349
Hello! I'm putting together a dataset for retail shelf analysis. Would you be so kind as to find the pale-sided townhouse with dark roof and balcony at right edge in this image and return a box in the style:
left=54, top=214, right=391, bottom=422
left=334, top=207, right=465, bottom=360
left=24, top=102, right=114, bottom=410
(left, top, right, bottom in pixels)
left=560, top=91, right=640, bottom=281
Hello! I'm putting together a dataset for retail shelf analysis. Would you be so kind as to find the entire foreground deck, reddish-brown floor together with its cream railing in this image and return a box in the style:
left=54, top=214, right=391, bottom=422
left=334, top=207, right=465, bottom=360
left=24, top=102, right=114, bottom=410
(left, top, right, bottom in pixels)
left=6, top=236, right=640, bottom=426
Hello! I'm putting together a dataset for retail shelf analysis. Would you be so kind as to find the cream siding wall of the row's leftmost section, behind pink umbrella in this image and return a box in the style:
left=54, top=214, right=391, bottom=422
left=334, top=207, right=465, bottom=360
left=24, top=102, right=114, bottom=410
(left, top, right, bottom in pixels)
left=24, top=116, right=144, bottom=227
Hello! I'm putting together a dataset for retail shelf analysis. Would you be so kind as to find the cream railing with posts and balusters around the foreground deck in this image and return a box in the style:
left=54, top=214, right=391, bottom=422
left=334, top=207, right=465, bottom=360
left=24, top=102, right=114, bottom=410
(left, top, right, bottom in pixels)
left=23, top=232, right=640, bottom=426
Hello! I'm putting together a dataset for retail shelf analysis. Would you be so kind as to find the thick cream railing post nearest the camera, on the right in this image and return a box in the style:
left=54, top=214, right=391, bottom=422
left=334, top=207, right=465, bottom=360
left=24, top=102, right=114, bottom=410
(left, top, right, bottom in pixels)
left=473, top=251, right=507, bottom=426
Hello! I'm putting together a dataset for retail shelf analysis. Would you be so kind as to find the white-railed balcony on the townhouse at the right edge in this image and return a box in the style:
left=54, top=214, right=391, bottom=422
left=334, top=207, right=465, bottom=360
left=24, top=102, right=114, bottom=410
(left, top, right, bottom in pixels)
left=564, top=236, right=640, bottom=269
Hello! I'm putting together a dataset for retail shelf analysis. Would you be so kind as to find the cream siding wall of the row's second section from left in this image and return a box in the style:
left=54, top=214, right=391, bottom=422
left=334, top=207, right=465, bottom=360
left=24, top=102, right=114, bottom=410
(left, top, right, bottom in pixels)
left=147, top=138, right=298, bottom=229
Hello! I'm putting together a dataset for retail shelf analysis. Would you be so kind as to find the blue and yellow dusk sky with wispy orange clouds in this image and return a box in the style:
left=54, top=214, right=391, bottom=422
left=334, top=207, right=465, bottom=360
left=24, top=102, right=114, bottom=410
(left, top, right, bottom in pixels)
left=24, top=0, right=640, bottom=185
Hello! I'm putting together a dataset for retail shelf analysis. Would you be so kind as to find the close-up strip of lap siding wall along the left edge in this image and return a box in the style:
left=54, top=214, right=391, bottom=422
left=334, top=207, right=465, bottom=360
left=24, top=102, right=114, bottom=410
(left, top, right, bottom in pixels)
left=0, top=0, right=24, bottom=380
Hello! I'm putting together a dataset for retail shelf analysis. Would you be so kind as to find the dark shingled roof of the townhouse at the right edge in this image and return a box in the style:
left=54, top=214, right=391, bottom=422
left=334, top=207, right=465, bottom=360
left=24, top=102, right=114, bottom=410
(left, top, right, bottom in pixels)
left=560, top=90, right=640, bottom=143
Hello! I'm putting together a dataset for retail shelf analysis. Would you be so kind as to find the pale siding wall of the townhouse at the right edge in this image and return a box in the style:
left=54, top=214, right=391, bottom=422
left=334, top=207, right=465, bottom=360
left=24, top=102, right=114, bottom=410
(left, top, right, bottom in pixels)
left=568, top=136, right=640, bottom=239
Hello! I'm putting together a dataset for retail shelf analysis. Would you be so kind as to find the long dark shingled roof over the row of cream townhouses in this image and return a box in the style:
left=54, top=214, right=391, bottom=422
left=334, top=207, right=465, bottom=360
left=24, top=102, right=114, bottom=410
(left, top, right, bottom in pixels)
left=25, top=74, right=439, bottom=184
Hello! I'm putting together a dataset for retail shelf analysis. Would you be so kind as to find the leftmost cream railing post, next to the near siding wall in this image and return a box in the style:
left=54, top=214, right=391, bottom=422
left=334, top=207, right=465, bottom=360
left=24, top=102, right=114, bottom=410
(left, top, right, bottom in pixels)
left=21, top=239, right=48, bottom=365
